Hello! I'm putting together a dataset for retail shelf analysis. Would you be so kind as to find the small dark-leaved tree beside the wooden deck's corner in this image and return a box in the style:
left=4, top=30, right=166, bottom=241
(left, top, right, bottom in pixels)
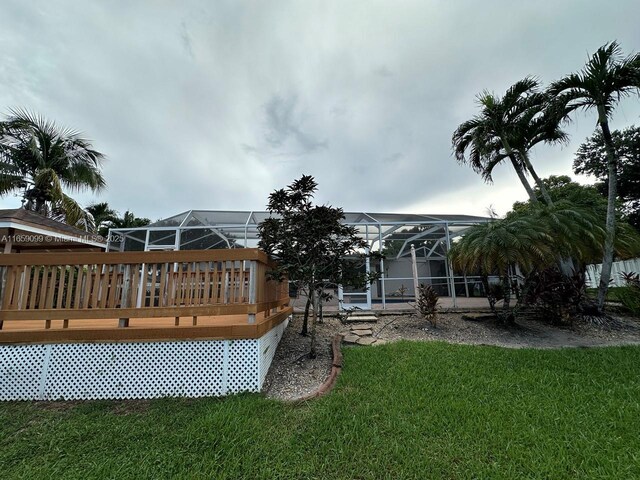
left=258, top=175, right=376, bottom=358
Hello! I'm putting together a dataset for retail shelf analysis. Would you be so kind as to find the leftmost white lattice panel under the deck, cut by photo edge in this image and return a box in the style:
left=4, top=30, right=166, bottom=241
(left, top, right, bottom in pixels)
left=0, top=345, right=50, bottom=400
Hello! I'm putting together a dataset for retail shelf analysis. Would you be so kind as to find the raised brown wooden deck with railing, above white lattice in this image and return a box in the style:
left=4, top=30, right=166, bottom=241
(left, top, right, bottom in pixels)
left=0, top=249, right=292, bottom=343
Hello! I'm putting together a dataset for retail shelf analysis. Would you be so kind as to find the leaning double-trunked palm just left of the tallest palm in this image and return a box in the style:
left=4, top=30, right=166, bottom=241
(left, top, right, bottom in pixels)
left=452, top=77, right=567, bottom=204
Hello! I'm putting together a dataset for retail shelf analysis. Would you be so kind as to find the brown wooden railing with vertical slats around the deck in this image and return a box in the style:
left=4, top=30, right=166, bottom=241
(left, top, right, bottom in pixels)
left=0, top=249, right=289, bottom=340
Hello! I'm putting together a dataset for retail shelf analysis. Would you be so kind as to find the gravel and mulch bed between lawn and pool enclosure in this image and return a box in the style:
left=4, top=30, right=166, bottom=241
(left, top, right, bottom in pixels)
left=264, top=313, right=640, bottom=400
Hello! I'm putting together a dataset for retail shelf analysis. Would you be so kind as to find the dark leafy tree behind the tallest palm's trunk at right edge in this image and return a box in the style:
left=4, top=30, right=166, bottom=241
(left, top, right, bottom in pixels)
left=573, top=125, right=640, bottom=231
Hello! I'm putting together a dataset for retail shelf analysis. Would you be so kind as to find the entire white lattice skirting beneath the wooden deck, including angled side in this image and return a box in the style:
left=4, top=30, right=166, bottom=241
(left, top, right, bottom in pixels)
left=0, top=320, right=289, bottom=400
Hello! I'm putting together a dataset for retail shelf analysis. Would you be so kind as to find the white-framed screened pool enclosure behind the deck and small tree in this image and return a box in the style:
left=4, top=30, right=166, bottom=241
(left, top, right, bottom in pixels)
left=108, top=210, right=490, bottom=309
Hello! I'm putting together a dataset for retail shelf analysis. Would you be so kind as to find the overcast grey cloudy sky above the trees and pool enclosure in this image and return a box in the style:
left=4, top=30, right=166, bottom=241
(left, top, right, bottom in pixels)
left=0, top=0, right=640, bottom=220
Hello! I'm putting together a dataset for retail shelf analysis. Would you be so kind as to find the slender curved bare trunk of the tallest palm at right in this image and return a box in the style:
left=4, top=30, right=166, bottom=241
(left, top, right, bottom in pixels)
left=597, top=111, right=618, bottom=313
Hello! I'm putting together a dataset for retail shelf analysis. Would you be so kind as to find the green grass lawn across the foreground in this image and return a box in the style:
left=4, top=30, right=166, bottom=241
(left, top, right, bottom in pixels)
left=0, top=342, right=640, bottom=479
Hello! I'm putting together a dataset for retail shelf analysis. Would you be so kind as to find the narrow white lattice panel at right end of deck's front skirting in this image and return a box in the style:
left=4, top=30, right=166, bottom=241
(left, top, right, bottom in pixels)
left=227, top=340, right=260, bottom=393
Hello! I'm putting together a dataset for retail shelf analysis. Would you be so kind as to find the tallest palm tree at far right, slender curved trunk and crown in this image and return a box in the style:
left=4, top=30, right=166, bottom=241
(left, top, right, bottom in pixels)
left=549, top=42, right=640, bottom=312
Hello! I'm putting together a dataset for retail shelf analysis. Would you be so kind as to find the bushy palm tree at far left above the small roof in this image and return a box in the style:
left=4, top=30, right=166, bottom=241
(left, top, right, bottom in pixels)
left=0, top=109, right=106, bottom=230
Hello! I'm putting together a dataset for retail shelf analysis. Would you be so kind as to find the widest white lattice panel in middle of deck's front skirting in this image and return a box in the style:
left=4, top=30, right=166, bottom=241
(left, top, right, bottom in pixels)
left=44, top=341, right=225, bottom=400
